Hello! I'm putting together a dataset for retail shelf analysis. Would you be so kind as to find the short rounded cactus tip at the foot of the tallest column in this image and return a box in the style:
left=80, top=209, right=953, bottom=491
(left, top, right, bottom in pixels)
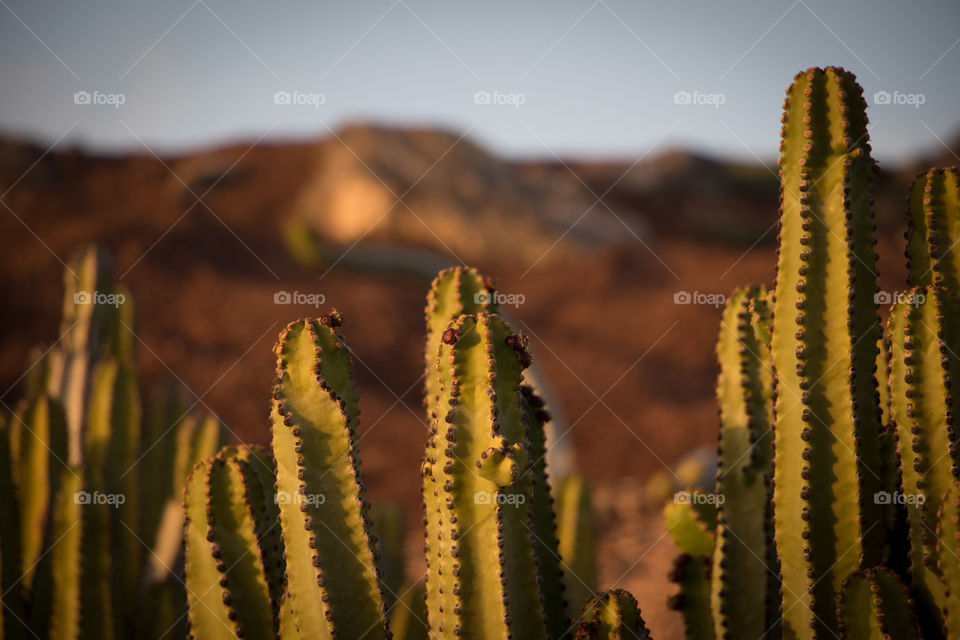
left=837, top=567, right=921, bottom=640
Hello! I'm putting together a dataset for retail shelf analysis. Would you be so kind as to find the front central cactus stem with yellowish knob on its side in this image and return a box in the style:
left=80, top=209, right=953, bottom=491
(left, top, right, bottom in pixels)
left=422, top=312, right=547, bottom=638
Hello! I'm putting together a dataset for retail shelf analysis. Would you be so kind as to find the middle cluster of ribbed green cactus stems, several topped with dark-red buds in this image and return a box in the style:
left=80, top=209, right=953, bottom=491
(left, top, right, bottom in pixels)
left=184, top=268, right=649, bottom=640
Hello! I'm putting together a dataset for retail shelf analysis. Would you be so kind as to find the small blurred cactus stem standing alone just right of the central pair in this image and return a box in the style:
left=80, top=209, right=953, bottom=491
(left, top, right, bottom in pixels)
left=556, top=475, right=597, bottom=620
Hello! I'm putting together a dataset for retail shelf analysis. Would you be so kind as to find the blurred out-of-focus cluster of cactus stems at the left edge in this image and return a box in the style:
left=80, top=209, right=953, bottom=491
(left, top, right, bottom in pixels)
left=0, top=247, right=223, bottom=640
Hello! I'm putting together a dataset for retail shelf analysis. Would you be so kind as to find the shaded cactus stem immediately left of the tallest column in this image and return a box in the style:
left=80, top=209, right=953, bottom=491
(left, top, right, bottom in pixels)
left=711, top=287, right=779, bottom=638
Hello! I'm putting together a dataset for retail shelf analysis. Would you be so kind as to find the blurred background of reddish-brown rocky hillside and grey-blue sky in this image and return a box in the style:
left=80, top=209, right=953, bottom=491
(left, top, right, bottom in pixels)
left=0, top=0, right=960, bottom=638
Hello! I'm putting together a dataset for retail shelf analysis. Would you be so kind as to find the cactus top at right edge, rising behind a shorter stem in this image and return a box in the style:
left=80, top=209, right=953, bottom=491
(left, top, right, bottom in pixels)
left=906, top=167, right=960, bottom=291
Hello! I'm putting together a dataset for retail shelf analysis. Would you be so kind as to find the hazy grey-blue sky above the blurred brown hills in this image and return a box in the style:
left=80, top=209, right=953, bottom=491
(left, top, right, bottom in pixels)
left=0, top=0, right=960, bottom=164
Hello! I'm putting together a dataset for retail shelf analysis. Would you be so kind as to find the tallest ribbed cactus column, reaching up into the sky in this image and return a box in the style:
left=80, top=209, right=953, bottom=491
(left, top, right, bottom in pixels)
left=772, top=67, right=883, bottom=638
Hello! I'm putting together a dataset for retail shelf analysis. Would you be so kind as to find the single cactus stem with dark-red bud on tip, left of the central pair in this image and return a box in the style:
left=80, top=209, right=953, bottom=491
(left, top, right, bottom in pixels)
left=272, top=311, right=386, bottom=638
